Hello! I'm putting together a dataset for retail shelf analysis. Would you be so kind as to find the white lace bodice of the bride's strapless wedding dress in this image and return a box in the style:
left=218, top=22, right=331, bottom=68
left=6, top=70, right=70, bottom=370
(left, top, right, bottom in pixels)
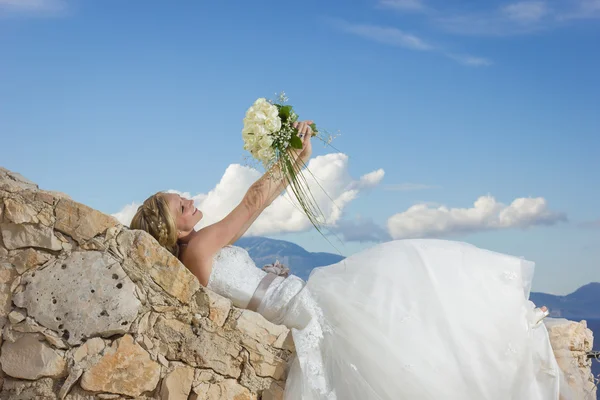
left=208, top=246, right=304, bottom=324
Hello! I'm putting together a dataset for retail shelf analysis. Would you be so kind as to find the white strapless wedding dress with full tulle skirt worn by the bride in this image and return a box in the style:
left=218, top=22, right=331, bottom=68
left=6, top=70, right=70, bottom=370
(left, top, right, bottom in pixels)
left=208, top=240, right=569, bottom=400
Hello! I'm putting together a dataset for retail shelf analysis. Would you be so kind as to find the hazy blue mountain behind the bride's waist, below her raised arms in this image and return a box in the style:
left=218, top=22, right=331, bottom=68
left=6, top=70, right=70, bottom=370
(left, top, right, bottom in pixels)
left=235, top=236, right=345, bottom=280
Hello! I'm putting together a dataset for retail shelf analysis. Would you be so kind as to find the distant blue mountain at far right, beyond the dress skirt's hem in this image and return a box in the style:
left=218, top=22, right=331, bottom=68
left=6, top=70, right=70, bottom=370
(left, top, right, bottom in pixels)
left=530, top=282, right=600, bottom=320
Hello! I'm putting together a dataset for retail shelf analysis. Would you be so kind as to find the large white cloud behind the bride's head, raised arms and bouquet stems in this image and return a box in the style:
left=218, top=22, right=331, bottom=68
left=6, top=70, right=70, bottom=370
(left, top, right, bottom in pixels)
left=113, top=153, right=384, bottom=235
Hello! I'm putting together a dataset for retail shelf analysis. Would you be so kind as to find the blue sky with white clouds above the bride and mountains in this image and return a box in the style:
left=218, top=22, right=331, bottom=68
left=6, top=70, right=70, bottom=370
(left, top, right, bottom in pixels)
left=0, top=0, right=600, bottom=293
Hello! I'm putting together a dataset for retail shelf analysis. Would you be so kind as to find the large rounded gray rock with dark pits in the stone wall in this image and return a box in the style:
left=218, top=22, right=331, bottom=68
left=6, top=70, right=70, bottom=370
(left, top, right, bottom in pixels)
left=13, top=251, right=141, bottom=345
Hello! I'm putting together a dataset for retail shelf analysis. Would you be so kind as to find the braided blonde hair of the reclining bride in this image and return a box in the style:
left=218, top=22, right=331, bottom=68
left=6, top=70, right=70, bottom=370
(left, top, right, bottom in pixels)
left=129, top=192, right=179, bottom=256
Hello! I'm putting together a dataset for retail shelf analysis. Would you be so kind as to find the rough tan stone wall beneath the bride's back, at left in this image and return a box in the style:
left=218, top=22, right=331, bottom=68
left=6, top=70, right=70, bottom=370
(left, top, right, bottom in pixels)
left=0, top=168, right=293, bottom=400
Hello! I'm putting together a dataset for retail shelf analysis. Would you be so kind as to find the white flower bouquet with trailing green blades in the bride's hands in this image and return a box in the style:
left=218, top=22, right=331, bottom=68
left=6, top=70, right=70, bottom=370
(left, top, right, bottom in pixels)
left=242, top=93, right=333, bottom=232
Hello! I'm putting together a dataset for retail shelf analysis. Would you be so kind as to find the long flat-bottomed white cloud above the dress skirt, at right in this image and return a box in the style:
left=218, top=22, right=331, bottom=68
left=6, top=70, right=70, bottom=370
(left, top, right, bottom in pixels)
left=387, top=196, right=566, bottom=239
